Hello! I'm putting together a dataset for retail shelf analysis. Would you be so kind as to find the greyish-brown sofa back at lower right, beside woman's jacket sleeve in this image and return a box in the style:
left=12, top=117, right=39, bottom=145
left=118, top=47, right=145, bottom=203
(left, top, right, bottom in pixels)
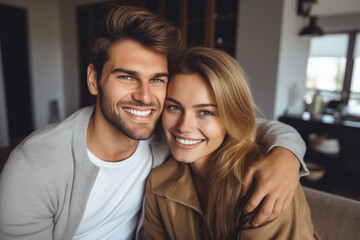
left=303, top=187, right=360, bottom=240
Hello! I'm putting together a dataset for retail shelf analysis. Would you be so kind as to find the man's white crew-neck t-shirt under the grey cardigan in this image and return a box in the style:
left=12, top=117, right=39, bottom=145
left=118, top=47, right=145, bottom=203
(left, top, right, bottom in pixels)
left=74, top=140, right=152, bottom=240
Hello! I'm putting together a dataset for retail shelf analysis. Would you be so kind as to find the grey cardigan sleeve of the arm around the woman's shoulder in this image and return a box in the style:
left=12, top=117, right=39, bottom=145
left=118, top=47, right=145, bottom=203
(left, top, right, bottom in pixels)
left=256, top=118, right=309, bottom=176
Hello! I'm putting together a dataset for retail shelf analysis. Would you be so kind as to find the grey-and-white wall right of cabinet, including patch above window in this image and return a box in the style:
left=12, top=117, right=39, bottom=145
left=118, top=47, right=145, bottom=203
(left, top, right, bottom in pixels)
left=235, top=0, right=360, bottom=119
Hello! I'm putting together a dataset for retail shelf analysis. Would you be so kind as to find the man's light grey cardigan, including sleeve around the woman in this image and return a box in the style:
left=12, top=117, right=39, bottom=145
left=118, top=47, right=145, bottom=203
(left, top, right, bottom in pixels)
left=0, top=106, right=307, bottom=240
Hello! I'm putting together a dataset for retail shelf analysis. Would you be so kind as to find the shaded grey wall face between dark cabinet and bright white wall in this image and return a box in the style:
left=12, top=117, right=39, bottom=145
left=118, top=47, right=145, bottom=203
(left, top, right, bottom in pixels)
left=235, top=0, right=283, bottom=119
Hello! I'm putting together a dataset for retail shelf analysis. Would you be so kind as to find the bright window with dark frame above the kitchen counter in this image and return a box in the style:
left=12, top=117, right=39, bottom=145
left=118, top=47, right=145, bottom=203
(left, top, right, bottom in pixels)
left=305, top=31, right=360, bottom=116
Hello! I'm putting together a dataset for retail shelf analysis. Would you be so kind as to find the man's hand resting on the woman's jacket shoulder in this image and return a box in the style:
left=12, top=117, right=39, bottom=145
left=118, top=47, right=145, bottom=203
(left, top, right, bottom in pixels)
left=242, top=147, right=300, bottom=227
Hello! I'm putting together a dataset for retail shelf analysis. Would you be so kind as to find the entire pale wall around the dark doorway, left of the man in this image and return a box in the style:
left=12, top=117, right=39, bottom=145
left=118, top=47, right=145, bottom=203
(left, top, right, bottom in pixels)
left=0, top=0, right=107, bottom=148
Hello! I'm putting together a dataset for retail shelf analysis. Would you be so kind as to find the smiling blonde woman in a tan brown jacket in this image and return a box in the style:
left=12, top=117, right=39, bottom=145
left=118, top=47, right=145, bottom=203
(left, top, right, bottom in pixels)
left=144, top=47, right=317, bottom=239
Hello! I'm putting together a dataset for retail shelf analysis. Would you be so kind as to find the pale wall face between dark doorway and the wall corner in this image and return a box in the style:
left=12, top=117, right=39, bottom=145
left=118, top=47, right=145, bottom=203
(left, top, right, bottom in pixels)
left=0, top=0, right=64, bottom=129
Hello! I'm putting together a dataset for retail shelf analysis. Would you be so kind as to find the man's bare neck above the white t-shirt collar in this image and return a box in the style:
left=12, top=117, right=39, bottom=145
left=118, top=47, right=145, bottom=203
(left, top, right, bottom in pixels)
left=86, top=110, right=139, bottom=162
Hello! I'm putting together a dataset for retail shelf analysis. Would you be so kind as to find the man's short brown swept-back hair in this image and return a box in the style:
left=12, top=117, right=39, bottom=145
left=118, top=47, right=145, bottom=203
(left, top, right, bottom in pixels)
left=90, top=5, right=183, bottom=80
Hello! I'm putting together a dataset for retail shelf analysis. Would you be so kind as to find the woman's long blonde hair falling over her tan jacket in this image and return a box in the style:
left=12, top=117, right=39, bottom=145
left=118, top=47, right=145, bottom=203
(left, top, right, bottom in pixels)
left=170, top=47, right=260, bottom=239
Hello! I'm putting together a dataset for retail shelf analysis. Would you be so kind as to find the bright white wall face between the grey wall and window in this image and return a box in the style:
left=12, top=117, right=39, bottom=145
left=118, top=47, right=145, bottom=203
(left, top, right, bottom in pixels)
left=270, top=0, right=310, bottom=119
